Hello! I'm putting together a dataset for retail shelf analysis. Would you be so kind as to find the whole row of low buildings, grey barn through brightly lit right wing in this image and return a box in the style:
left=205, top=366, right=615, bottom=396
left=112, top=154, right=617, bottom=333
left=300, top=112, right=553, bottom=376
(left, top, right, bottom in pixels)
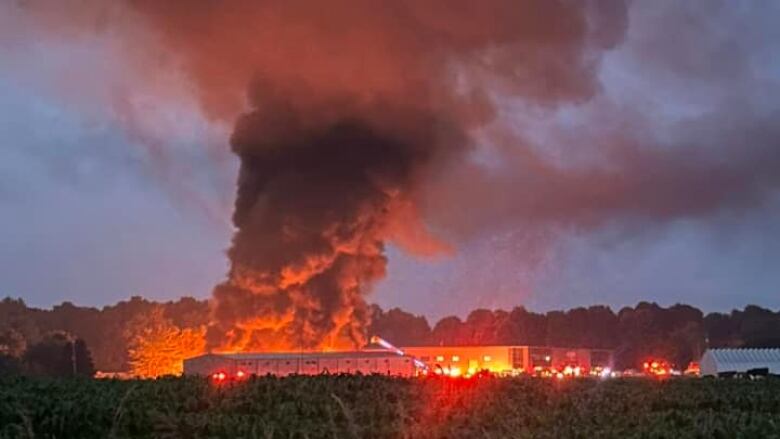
left=184, top=337, right=612, bottom=379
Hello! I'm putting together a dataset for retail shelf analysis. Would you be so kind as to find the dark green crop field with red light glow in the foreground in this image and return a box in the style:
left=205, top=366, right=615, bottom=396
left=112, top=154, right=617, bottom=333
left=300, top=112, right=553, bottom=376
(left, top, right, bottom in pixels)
left=0, top=376, right=780, bottom=439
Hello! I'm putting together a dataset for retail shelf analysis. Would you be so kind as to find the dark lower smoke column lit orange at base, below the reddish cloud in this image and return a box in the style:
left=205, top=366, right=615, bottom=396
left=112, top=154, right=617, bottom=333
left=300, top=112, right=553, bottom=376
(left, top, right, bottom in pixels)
left=210, top=93, right=464, bottom=349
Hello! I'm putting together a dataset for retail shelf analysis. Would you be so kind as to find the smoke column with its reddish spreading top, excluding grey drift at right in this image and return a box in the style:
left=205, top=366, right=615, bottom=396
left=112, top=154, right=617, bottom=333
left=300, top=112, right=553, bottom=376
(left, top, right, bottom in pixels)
left=13, top=0, right=627, bottom=350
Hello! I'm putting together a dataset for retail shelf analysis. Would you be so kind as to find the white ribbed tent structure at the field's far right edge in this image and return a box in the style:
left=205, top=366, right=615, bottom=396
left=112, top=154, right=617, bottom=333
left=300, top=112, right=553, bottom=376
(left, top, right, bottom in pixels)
left=700, top=349, right=780, bottom=376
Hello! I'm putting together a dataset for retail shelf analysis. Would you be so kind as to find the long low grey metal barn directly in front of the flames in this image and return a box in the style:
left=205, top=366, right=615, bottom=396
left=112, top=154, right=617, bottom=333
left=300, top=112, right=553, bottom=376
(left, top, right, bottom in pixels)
left=184, top=351, right=418, bottom=379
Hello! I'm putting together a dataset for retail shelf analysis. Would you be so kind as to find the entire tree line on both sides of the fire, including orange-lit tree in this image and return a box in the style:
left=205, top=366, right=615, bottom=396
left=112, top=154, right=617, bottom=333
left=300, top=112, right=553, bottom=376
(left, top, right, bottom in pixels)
left=0, top=296, right=780, bottom=376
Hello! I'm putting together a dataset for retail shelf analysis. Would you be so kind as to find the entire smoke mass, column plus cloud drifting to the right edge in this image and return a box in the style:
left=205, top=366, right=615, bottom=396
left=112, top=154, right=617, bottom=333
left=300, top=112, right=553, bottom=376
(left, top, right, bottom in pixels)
left=7, top=0, right=780, bottom=334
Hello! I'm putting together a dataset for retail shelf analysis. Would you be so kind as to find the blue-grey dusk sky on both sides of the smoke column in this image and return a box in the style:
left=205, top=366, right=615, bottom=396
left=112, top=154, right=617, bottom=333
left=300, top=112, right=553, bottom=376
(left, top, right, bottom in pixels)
left=0, top=0, right=780, bottom=319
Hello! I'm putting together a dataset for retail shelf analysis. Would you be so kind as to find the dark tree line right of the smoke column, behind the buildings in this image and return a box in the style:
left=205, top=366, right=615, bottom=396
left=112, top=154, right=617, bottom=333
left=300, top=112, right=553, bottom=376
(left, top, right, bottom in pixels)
left=371, top=302, right=780, bottom=369
